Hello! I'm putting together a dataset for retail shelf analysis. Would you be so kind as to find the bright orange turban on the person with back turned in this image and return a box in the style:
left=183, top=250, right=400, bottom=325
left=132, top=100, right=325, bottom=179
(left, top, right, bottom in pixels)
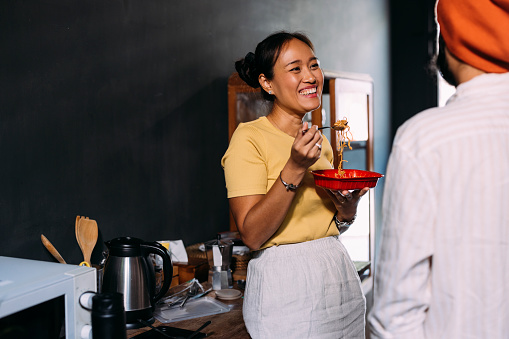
left=436, top=0, right=509, bottom=73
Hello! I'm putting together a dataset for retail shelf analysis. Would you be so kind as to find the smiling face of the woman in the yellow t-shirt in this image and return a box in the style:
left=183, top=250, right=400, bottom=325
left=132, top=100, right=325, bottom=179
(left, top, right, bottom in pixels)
left=269, top=39, right=323, bottom=114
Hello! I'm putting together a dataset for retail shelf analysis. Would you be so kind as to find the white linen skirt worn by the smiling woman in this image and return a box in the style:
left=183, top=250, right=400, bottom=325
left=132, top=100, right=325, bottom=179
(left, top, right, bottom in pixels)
left=243, top=236, right=366, bottom=339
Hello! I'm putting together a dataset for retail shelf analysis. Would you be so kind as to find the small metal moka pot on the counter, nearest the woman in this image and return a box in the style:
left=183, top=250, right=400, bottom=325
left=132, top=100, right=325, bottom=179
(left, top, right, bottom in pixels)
left=205, top=234, right=233, bottom=290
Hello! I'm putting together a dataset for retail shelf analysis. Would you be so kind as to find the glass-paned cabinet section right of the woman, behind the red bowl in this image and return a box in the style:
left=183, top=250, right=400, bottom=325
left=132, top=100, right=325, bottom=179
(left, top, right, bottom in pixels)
left=322, top=72, right=375, bottom=284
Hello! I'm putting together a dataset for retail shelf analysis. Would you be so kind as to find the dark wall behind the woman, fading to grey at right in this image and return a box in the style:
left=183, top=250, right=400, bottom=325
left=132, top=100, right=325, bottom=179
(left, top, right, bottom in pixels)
left=0, top=0, right=389, bottom=263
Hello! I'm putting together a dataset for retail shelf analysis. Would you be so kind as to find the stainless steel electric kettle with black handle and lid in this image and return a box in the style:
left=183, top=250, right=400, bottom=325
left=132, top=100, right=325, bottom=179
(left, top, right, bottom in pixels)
left=102, top=237, right=173, bottom=329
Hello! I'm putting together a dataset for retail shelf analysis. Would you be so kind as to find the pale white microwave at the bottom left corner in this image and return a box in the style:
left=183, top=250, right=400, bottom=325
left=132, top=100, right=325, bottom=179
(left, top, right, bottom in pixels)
left=0, top=256, right=97, bottom=339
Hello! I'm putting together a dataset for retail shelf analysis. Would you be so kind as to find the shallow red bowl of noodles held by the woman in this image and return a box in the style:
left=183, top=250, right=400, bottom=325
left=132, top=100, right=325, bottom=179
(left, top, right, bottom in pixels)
left=311, top=169, right=383, bottom=190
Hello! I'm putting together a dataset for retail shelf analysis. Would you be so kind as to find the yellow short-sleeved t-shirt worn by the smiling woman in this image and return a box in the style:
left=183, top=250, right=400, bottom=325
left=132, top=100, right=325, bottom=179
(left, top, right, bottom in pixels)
left=221, top=117, right=339, bottom=249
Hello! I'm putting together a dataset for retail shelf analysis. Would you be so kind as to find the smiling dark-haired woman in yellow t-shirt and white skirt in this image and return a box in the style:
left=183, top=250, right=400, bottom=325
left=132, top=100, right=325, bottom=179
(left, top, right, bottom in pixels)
left=222, top=32, right=368, bottom=338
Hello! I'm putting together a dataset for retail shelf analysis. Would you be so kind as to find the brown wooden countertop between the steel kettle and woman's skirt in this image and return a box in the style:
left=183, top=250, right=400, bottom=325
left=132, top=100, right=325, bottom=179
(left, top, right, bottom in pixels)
left=127, top=284, right=251, bottom=339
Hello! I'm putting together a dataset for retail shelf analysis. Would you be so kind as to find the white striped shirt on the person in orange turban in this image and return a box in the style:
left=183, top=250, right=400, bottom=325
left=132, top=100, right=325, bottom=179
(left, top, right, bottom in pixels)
left=368, top=73, right=509, bottom=339
